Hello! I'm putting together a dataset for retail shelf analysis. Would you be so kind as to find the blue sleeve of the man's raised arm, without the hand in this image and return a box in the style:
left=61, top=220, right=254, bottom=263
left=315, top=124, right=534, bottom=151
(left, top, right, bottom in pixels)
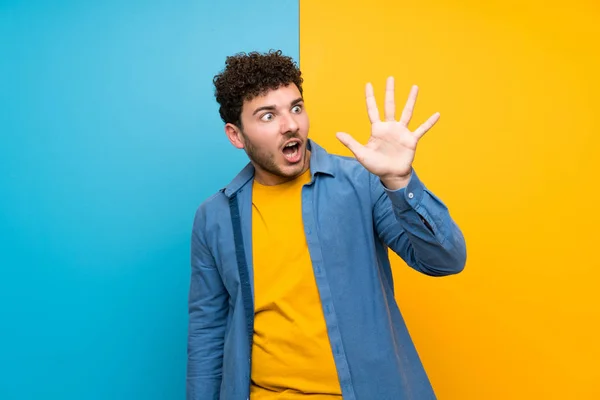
left=370, top=171, right=466, bottom=276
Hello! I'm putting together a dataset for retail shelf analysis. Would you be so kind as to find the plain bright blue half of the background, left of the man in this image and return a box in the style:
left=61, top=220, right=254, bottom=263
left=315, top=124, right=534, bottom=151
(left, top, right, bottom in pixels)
left=0, top=0, right=299, bottom=400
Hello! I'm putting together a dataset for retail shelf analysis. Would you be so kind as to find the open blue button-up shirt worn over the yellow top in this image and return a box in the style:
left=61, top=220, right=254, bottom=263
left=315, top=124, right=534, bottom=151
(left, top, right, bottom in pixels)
left=187, top=141, right=466, bottom=400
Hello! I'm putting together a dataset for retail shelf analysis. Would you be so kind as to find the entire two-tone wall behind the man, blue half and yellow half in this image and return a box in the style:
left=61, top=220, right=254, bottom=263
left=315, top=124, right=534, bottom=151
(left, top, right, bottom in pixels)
left=0, top=0, right=600, bottom=400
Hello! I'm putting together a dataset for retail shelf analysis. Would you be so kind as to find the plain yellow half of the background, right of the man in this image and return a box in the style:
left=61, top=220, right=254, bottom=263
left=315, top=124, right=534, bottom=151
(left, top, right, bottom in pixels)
left=300, top=0, right=600, bottom=400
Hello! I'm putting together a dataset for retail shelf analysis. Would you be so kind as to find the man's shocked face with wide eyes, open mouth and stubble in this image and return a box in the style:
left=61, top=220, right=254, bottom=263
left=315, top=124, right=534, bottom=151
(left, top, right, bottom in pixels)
left=225, top=84, right=310, bottom=185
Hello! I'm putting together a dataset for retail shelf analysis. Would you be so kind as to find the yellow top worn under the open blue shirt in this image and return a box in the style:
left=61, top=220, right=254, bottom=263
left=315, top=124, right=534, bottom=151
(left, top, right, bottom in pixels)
left=251, top=171, right=341, bottom=400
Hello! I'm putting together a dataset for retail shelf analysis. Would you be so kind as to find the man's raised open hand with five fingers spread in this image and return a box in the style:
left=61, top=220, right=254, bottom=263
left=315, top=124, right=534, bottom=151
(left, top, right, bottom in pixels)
left=336, top=77, right=440, bottom=190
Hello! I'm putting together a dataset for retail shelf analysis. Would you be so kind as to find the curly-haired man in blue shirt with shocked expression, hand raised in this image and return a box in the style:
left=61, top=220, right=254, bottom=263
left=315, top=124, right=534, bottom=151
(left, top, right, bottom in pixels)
left=187, top=51, right=466, bottom=400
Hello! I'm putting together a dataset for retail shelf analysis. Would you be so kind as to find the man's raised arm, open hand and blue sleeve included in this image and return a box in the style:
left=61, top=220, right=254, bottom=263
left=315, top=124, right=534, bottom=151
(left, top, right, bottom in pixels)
left=337, top=77, right=466, bottom=276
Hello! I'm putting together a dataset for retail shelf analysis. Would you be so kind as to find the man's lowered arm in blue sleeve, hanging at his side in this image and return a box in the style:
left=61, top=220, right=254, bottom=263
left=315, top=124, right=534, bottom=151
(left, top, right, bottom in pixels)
left=186, top=206, right=228, bottom=400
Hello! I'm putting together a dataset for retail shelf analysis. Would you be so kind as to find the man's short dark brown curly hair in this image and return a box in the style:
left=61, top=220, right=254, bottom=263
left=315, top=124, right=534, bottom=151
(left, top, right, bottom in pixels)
left=213, top=50, right=303, bottom=127
